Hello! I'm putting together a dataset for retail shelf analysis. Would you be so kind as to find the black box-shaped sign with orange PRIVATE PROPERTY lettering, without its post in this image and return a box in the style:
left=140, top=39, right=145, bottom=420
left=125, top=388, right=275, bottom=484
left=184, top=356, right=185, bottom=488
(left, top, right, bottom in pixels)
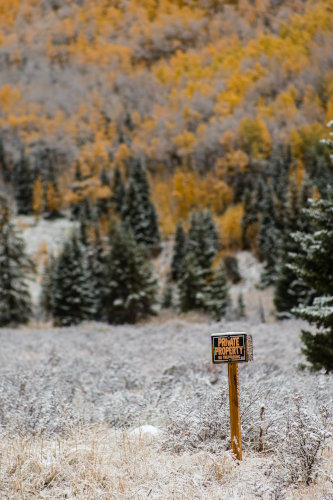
left=211, top=332, right=253, bottom=363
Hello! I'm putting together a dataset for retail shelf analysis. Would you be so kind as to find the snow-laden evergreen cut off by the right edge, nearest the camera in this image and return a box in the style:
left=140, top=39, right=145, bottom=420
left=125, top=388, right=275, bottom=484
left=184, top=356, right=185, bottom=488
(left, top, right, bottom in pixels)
left=290, top=187, right=333, bottom=372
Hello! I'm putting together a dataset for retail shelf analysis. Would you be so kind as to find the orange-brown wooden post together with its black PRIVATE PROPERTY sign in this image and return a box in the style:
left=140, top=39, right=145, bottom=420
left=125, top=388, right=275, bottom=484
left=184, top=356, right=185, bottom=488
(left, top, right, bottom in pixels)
left=211, top=332, right=253, bottom=460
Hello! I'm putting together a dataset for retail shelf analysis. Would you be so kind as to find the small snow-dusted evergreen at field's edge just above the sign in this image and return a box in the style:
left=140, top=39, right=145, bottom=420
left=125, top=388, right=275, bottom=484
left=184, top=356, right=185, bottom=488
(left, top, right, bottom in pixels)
left=205, top=262, right=230, bottom=321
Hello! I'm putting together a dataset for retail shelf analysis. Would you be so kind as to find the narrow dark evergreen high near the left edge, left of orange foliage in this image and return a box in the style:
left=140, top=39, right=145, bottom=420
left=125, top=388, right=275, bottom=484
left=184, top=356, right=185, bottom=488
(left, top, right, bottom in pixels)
left=13, top=150, right=34, bottom=215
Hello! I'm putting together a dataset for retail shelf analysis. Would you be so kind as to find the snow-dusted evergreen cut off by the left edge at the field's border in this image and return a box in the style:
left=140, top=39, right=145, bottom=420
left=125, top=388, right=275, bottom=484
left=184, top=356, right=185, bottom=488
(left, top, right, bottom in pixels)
left=0, top=196, right=33, bottom=326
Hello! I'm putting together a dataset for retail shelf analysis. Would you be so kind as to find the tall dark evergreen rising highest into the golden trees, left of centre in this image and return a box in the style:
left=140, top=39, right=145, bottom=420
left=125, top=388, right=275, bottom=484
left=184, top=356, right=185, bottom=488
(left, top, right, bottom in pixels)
left=122, top=161, right=160, bottom=252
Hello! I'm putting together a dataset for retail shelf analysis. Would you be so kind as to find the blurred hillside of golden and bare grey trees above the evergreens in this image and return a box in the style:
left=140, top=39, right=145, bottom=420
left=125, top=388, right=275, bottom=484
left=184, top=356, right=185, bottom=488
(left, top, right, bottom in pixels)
left=0, top=0, right=333, bottom=235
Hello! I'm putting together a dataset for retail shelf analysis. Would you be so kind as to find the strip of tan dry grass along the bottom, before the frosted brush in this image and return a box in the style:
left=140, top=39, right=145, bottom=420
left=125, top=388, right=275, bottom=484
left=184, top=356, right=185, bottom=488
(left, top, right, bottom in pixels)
left=0, top=427, right=333, bottom=500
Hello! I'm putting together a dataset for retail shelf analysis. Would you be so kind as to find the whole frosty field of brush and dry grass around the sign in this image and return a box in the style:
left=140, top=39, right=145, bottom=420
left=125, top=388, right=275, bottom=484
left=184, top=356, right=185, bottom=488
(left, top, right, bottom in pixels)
left=0, top=315, right=333, bottom=500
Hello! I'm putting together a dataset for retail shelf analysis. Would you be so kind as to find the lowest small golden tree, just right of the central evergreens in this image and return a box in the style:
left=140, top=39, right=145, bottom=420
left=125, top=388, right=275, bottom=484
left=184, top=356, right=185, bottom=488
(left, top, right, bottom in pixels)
left=219, top=203, right=244, bottom=250
